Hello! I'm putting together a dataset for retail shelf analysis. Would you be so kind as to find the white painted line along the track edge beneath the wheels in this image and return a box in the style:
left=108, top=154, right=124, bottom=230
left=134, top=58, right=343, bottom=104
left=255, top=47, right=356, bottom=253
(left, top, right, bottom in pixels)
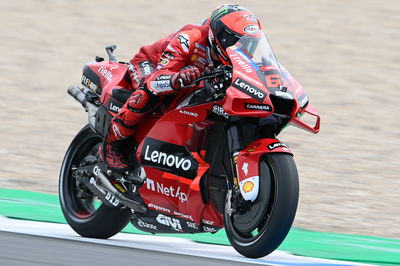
left=0, top=216, right=367, bottom=266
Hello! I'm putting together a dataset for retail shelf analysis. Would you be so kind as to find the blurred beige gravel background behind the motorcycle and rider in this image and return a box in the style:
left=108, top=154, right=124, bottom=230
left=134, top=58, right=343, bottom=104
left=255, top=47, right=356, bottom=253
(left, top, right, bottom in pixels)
left=0, top=0, right=400, bottom=238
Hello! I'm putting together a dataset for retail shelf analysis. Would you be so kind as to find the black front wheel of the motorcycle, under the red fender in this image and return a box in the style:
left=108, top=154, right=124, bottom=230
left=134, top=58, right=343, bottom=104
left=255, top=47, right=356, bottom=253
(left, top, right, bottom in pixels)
left=224, top=153, right=299, bottom=258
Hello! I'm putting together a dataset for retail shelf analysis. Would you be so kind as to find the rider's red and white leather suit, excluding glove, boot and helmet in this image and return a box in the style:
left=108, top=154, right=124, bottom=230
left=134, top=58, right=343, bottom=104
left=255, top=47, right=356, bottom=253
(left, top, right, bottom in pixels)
left=113, top=23, right=210, bottom=139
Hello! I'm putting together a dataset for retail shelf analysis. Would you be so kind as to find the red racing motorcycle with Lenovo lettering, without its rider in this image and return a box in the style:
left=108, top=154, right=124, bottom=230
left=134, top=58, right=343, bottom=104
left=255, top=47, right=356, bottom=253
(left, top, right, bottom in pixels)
left=59, top=35, right=320, bottom=258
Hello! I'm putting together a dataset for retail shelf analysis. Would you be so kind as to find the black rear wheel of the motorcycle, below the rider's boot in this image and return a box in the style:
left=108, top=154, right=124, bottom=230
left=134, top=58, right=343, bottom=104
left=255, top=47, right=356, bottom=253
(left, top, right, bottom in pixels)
left=59, top=125, right=132, bottom=239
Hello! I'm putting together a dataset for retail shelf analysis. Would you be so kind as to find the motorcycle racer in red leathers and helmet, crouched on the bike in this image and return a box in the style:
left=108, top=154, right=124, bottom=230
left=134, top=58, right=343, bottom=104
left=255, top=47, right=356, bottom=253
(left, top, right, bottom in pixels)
left=100, top=4, right=261, bottom=183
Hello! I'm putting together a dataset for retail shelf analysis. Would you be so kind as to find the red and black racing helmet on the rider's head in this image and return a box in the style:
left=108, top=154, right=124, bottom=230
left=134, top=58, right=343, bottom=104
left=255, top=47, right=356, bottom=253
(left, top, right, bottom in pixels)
left=208, top=4, right=261, bottom=65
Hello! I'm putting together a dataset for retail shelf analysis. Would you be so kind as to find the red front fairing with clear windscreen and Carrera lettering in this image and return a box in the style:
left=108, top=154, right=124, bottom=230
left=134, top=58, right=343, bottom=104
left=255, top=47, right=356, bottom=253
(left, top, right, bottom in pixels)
left=223, top=34, right=319, bottom=133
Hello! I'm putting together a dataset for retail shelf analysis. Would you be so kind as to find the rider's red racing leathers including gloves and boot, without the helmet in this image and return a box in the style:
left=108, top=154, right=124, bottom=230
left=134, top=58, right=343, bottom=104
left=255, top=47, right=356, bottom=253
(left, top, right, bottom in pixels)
left=101, top=23, right=212, bottom=173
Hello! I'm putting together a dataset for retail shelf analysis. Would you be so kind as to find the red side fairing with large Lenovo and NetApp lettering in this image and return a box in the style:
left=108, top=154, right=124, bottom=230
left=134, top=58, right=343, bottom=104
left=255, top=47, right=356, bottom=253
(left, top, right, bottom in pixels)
left=137, top=103, right=223, bottom=227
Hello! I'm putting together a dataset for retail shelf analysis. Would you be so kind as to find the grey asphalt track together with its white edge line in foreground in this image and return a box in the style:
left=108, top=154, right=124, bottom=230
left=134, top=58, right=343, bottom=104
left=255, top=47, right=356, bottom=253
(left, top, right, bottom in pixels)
left=0, top=217, right=368, bottom=266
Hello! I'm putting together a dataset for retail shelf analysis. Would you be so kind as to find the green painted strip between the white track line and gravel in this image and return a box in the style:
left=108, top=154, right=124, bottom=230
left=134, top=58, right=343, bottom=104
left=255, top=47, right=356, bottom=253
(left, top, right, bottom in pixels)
left=0, top=189, right=400, bottom=265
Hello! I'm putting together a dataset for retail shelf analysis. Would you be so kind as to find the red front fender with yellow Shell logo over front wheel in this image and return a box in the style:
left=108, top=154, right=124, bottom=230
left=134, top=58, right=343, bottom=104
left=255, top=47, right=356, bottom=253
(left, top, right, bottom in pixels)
left=236, top=139, right=293, bottom=202
